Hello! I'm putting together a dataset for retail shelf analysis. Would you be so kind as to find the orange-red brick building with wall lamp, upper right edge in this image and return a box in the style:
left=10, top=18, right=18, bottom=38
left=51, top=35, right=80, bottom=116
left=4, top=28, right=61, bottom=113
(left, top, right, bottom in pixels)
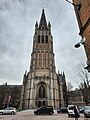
left=73, top=0, right=90, bottom=72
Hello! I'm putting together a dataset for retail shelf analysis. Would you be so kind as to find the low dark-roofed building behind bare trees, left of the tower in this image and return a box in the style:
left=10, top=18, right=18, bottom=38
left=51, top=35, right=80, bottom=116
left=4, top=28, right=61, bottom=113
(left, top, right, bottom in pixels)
left=0, top=83, right=21, bottom=108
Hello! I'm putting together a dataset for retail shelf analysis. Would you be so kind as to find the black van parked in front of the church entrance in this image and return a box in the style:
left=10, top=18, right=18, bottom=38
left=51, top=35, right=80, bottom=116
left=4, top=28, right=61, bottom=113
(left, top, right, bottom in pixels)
left=34, top=106, right=54, bottom=115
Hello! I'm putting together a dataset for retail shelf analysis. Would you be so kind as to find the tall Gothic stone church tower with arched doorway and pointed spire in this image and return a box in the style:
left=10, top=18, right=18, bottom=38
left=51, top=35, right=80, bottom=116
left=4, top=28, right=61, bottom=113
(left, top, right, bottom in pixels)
left=20, top=9, right=65, bottom=108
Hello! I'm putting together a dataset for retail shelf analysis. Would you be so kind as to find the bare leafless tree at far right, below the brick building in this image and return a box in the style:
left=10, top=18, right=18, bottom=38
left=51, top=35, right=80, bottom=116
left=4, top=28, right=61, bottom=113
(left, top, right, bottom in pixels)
left=77, top=63, right=90, bottom=105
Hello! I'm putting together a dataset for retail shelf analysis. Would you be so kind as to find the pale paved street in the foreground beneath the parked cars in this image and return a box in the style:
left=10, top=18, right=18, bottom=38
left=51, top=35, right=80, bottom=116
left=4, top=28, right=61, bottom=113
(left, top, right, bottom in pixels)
left=0, top=110, right=90, bottom=120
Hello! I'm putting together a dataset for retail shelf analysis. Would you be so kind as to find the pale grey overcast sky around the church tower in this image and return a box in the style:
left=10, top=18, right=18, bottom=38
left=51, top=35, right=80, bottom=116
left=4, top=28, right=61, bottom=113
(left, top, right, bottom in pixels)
left=0, top=0, right=86, bottom=87
